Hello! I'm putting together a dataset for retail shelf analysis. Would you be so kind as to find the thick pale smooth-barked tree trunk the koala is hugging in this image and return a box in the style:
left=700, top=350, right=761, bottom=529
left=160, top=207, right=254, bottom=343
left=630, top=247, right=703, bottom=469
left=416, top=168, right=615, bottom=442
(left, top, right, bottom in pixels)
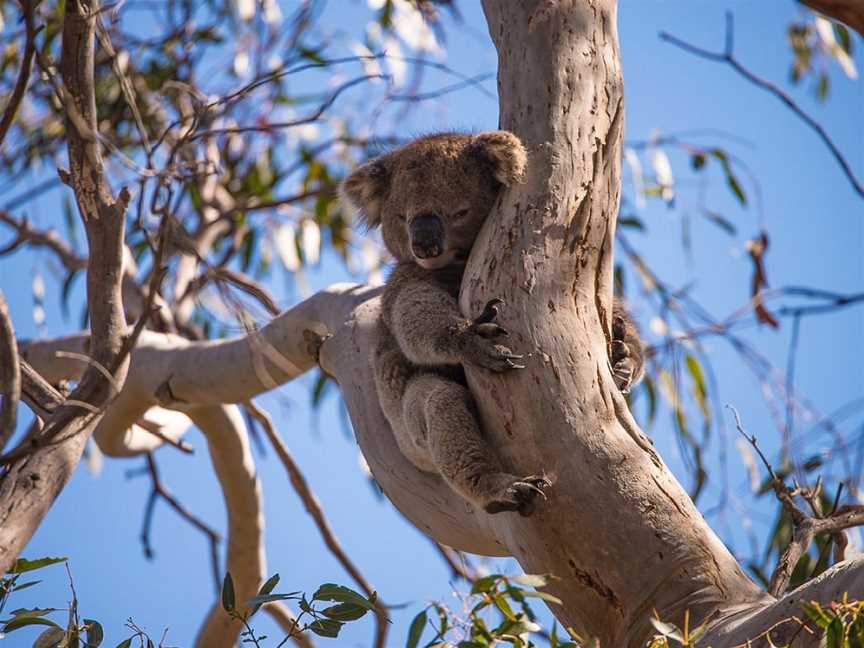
left=448, top=0, right=764, bottom=647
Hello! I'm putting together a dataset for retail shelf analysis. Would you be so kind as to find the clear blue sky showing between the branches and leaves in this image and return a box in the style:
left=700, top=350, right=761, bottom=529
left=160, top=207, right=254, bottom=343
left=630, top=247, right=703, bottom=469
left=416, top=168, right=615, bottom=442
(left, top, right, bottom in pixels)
left=0, top=0, right=864, bottom=647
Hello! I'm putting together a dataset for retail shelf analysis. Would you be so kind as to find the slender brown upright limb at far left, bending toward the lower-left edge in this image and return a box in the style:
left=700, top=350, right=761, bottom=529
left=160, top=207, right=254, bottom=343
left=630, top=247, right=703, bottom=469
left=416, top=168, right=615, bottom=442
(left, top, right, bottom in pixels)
left=0, top=0, right=129, bottom=573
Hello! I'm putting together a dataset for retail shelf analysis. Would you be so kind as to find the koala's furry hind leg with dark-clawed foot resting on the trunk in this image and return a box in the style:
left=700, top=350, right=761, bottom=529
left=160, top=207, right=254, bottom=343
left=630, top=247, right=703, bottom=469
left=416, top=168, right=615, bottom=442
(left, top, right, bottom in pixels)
left=402, top=373, right=551, bottom=516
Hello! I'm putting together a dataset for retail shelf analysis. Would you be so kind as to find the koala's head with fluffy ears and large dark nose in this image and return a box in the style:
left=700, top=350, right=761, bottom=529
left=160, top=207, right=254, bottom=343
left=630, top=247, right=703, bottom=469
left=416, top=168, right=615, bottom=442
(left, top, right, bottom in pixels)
left=342, top=131, right=527, bottom=270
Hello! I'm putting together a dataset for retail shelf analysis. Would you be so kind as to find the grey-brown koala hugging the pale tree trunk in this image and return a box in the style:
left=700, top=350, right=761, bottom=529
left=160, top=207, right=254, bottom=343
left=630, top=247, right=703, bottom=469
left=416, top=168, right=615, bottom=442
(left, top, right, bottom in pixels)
left=341, top=131, right=643, bottom=516
